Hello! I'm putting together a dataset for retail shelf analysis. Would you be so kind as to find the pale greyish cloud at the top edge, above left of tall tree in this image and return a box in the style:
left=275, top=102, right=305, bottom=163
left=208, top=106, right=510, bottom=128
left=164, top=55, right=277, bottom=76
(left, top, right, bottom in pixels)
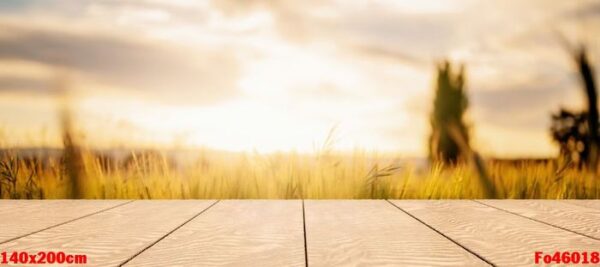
left=212, top=0, right=459, bottom=58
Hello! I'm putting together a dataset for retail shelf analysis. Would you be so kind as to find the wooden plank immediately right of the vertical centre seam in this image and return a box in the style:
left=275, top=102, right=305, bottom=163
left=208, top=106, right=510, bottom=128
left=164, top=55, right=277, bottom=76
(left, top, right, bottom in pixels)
left=305, top=200, right=487, bottom=266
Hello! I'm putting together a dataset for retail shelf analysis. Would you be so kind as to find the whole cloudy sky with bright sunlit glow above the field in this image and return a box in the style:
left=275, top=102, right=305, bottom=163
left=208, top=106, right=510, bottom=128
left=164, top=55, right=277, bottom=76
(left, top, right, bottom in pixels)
left=0, top=0, right=600, bottom=157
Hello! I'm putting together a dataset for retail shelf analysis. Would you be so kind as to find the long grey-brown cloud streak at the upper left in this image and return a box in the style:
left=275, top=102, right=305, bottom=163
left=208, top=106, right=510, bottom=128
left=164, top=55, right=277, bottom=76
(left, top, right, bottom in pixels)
left=0, top=25, right=239, bottom=103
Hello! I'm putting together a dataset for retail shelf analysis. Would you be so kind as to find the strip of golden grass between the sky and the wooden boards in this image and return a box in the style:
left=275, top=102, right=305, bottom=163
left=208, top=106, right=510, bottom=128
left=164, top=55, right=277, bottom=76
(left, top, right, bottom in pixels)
left=0, top=151, right=600, bottom=199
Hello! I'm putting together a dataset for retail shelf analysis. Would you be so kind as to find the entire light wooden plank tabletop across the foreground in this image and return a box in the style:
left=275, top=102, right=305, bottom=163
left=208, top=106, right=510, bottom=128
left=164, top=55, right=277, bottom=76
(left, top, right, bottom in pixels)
left=0, top=200, right=600, bottom=266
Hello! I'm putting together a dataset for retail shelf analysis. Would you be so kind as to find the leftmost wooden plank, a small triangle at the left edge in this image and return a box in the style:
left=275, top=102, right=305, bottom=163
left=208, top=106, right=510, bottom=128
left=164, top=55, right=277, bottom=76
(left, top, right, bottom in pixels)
left=0, top=200, right=127, bottom=243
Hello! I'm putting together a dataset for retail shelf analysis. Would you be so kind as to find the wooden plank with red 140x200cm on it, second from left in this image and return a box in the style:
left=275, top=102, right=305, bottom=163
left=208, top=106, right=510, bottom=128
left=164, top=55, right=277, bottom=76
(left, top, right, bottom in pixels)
left=0, top=200, right=214, bottom=266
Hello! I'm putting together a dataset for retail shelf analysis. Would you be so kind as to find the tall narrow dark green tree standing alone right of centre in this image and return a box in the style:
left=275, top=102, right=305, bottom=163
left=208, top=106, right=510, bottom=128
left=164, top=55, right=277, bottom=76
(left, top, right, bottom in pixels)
left=429, top=61, right=469, bottom=163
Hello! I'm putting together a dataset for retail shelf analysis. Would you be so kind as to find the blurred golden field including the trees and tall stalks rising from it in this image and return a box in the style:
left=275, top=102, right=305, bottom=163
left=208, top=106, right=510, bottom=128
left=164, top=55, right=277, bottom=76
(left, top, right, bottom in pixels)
left=0, top=38, right=600, bottom=199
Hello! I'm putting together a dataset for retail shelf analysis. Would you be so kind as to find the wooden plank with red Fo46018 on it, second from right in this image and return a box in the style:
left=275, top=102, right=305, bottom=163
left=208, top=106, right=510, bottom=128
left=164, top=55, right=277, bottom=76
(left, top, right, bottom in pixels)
left=392, top=200, right=600, bottom=266
